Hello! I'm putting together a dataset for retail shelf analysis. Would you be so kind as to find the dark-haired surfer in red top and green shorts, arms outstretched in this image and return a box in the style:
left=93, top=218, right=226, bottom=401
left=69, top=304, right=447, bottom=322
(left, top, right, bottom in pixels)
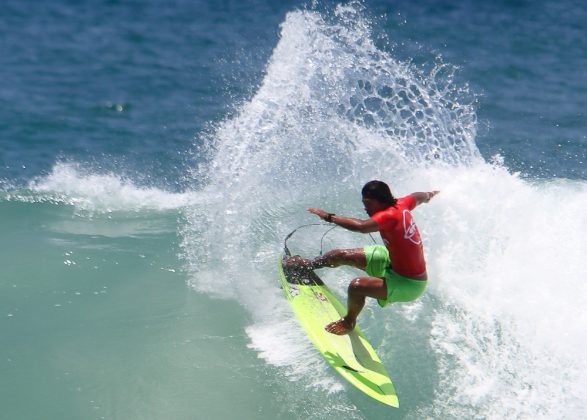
left=284, top=181, right=438, bottom=335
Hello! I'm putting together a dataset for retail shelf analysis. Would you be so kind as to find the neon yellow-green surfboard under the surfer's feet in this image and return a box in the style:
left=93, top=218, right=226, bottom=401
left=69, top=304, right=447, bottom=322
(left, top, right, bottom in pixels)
left=279, top=258, right=399, bottom=407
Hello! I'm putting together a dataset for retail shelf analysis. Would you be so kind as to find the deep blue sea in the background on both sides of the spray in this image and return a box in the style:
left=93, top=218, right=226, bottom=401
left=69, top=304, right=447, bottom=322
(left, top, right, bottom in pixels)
left=0, top=1, right=587, bottom=188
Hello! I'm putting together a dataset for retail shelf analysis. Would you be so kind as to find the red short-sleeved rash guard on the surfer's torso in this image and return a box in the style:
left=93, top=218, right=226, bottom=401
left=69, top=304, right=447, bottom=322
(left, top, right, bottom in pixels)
left=371, top=195, right=426, bottom=277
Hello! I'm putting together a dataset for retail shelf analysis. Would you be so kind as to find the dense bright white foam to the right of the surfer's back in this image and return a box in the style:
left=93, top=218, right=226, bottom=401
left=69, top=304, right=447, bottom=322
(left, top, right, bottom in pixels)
left=421, top=165, right=587, bottom=418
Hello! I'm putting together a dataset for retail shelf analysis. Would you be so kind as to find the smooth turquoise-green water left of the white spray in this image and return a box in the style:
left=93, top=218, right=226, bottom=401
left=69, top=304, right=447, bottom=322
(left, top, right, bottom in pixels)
left=1, top=199, right=280, bottom=419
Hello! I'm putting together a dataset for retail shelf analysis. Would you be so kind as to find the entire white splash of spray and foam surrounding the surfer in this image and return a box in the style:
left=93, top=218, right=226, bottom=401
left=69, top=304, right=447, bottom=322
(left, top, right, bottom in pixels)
left=182, top=4, right=587, bottom=418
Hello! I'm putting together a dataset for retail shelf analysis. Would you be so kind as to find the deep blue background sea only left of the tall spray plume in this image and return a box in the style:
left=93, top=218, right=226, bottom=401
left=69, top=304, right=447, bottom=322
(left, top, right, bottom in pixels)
left=0, top=1, right=294, bottom=187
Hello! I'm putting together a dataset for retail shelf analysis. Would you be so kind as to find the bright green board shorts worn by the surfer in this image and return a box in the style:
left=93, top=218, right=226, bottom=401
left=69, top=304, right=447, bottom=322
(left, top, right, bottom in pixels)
left=363, top=245, right=428, bottom=307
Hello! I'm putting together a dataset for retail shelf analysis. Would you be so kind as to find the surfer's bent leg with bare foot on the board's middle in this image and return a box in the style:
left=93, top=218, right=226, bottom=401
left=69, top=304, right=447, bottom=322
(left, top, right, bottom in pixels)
left=325, top=277, right=387, bottom=335
